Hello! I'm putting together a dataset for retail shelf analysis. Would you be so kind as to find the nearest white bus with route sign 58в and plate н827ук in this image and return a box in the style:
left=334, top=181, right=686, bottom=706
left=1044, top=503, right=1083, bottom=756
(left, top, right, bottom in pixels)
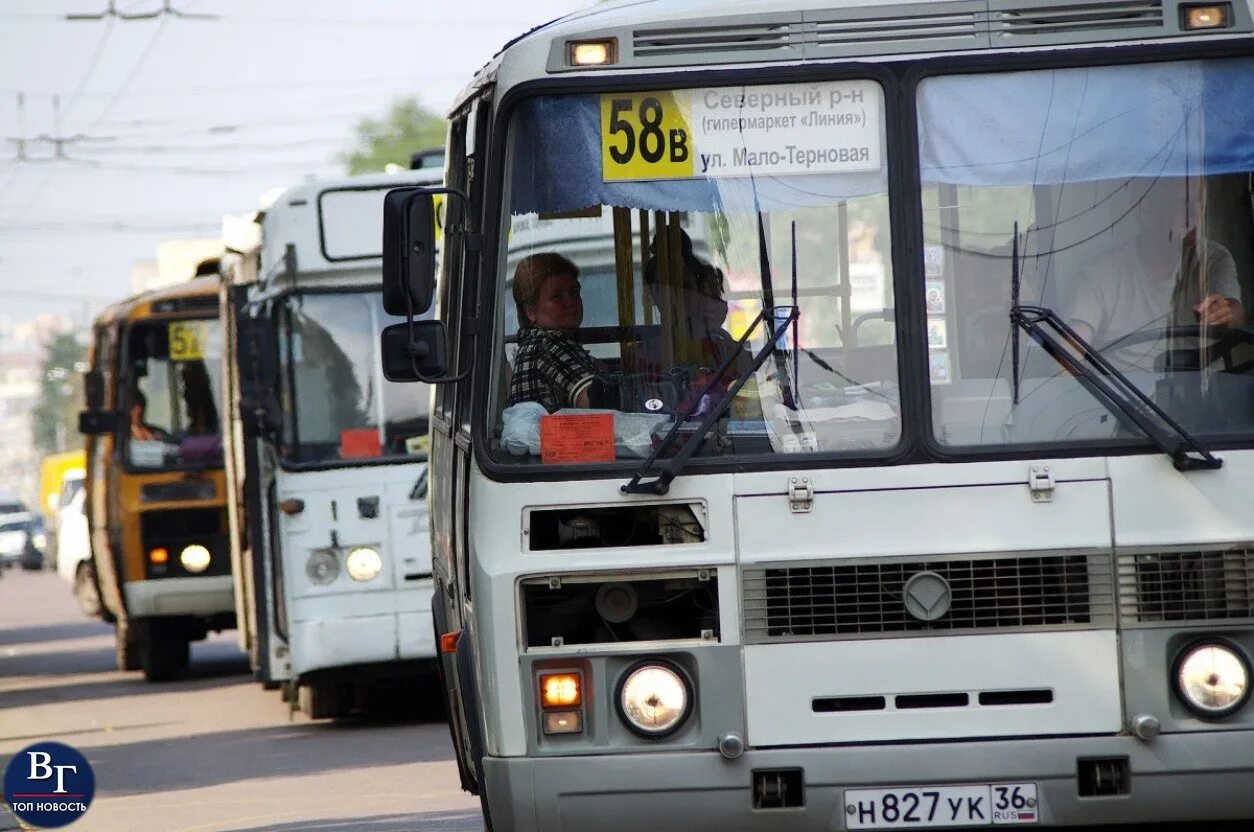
left=384, top=0, right=1254, bottom=832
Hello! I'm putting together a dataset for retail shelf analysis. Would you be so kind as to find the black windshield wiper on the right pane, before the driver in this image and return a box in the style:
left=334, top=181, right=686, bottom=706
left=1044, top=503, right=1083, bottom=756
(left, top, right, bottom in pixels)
left=1011, top=304, right=1224, bottom=471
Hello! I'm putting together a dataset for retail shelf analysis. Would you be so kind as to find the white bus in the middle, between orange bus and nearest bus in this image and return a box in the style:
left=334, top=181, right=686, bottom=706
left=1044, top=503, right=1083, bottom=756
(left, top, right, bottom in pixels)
left=223, top=169, right=441, bottom=718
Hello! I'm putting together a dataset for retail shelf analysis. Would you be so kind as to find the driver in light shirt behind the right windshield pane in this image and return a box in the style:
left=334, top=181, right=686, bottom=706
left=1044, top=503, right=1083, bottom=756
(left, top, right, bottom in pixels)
left=1068, top=179, right=1245, bottom=348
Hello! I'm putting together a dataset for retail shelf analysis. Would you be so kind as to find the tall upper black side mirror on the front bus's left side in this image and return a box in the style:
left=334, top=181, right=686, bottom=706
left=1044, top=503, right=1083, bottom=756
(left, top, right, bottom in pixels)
left=384, top=188, right=435, bottom=315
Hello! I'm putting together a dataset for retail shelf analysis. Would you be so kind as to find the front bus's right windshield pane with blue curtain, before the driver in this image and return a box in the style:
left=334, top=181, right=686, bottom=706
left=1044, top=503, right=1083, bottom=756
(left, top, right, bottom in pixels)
left=917, top=59, right=1254, bottom=447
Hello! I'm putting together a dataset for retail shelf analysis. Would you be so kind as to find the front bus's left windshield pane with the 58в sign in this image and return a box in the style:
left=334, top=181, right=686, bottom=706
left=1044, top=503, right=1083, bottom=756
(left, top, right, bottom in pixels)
left=485, top=79, right=902, bottom=463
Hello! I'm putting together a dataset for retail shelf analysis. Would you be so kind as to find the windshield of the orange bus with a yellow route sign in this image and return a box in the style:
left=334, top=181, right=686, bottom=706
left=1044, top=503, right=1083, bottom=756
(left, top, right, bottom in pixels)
left=124, top=319, right=222, bottom=469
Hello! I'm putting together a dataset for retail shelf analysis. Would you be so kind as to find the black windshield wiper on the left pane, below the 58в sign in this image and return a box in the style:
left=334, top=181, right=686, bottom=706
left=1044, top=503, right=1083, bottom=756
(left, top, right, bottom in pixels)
left=619, top=306, right=798, bottom=494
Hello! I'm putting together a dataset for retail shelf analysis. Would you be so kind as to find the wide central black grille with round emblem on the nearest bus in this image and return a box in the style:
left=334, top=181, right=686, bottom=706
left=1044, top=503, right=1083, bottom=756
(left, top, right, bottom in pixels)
left=744, top=553, right=1115, bottom=643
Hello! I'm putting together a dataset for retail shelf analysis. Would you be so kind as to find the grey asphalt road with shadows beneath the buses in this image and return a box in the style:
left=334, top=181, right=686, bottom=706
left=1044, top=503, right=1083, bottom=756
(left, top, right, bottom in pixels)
left=0, top=570, right=483, bottom=832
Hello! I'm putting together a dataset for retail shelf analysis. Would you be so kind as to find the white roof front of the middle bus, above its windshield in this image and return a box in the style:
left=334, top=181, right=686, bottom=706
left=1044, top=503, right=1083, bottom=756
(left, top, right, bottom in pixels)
left=260, top=168, right=444, bottom=285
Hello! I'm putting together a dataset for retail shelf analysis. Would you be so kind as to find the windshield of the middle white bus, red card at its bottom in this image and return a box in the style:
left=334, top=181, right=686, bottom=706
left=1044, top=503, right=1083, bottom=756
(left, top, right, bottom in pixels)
left=278, top=291, right=429, bottom=464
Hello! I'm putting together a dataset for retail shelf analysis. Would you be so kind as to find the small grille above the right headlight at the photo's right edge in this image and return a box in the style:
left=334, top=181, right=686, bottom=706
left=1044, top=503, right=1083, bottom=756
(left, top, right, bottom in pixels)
left=1119, top=546, right=1254, bottom=625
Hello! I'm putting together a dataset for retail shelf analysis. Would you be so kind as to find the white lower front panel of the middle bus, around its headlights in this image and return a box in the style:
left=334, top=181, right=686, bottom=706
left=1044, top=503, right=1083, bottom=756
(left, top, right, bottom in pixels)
left=276, top=463, right=435, bottom=676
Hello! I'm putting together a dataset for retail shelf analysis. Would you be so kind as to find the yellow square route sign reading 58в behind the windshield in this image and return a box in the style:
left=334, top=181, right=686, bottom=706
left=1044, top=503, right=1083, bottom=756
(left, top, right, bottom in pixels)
left=601, top=92, right=693, bottom=182
